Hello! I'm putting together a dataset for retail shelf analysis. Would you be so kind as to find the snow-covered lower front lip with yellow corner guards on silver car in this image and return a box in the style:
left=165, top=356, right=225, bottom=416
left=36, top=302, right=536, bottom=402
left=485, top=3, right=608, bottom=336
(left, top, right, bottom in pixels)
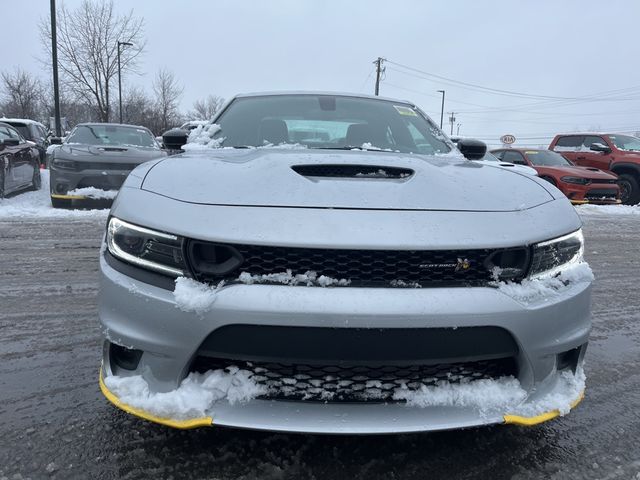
left=100, top=367, right=585, bottom=434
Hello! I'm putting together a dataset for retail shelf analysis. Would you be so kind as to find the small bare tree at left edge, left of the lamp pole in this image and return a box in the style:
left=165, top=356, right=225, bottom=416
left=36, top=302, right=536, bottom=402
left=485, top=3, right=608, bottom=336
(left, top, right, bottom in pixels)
left=0, top=68, right=47, bottom=120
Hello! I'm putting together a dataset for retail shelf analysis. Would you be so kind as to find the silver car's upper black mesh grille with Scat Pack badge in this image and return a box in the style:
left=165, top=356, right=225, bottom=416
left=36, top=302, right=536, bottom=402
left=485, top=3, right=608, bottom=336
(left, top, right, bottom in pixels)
left=186, top=240, right=529, bottom=288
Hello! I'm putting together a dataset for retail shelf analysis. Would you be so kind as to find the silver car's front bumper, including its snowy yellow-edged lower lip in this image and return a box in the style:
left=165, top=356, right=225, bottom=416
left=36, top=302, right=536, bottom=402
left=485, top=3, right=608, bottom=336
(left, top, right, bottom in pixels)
left=99, top=253, right=590, bottom=433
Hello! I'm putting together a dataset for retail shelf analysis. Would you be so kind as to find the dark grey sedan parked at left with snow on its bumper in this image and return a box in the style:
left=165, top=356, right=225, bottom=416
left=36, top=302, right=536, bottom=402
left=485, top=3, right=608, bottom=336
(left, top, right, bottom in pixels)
left=49, top=123, right=166, bottom=208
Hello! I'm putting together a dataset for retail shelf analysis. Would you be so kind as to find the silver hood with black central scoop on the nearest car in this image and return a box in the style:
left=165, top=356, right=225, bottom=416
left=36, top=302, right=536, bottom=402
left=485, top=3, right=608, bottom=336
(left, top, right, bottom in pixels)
left=141, top=148, right=553, bottom=211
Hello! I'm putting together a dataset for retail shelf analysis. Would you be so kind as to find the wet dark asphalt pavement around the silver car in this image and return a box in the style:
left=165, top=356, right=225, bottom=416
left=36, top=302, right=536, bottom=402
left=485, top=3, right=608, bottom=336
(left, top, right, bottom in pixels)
left=0, top=215, right=640, bottom=480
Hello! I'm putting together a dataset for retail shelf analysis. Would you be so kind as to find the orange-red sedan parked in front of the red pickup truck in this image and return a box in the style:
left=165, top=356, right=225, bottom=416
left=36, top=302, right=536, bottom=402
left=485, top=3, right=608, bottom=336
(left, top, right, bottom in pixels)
left=491, top=148, right=620, bottom=204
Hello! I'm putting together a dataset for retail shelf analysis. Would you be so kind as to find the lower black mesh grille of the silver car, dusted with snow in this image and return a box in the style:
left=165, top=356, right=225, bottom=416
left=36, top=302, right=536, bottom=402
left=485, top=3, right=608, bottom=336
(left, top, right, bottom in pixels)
left=191, top=356, right=517, bottom=403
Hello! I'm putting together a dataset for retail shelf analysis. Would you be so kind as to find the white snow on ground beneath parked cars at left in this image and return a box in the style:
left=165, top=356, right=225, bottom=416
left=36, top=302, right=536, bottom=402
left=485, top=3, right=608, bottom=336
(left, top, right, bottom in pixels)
left=0, top=170, right=109, bottom=220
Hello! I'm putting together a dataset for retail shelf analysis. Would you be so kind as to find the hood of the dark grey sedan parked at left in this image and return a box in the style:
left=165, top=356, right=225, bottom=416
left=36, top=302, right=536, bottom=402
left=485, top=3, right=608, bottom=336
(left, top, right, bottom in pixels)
left=55, top=143, right=166, bottom=163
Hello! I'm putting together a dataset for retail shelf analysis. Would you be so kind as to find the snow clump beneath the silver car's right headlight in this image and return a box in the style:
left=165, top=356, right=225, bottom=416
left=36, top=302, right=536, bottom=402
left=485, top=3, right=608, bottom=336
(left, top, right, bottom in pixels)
left=496, top=262, right=594, bottom=304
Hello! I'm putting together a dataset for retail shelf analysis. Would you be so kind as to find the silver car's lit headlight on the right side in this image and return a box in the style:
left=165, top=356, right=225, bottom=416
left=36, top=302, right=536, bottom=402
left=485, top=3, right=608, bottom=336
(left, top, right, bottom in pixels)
left=529, top=229, right=584, bottom=277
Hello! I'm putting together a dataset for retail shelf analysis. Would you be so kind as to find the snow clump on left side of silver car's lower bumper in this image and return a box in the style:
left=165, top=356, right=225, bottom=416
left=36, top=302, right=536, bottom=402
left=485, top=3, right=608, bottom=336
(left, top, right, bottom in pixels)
left=104, top=367, right=266, bottom=420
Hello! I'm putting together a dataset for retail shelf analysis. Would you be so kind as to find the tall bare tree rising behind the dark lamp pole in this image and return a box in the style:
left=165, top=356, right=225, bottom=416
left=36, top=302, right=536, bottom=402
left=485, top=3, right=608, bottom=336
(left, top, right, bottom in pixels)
left=40, top=0, right=145, bottom=122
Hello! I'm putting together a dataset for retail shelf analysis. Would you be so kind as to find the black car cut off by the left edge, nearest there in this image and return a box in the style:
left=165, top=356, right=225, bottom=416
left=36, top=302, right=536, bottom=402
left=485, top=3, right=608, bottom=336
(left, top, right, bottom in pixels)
left=0, top=122, right=41, bottom=198
